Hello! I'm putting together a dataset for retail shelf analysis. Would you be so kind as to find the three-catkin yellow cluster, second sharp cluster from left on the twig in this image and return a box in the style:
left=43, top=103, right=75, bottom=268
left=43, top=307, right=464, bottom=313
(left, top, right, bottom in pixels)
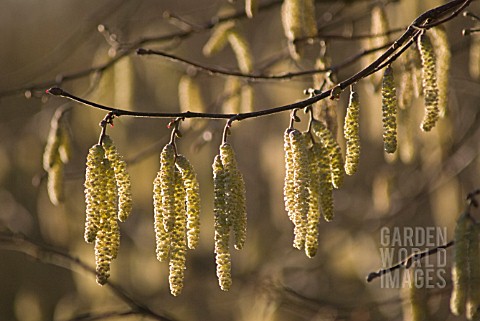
left=153, top=144, right=200, bottom=296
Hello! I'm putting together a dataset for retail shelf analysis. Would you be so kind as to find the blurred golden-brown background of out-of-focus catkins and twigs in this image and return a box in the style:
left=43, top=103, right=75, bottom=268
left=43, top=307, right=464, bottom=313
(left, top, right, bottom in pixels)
left=0, top=0, right=480, bottom=321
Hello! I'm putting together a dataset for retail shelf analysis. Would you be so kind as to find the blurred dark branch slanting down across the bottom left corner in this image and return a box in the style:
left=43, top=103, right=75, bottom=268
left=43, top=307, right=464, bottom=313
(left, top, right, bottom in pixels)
left=0, top=231, right=175, bottom=321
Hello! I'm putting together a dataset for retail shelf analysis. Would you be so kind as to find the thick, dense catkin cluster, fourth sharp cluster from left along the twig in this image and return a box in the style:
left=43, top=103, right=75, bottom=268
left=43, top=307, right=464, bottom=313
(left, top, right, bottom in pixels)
left=284, top=128, right=333, bottom=257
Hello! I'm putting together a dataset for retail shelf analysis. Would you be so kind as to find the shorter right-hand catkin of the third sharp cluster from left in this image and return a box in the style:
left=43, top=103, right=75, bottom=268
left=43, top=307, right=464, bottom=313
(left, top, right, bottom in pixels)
left=220, top=143, right=247, bottom=250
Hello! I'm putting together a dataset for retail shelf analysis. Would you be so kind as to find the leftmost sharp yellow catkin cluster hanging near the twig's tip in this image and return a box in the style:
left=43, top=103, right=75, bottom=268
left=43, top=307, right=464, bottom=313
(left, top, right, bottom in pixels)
left=84, top=135, right=132, bottom=285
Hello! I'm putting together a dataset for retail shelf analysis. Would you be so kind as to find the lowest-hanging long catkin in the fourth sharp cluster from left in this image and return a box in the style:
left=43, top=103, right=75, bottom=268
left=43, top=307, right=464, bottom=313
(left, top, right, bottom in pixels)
left=305, top=138, right=322, bottom=257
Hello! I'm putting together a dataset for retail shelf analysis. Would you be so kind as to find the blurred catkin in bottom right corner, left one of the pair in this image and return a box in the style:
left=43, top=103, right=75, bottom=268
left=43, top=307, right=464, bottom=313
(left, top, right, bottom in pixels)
left=450, top=213, right=472, bottom=315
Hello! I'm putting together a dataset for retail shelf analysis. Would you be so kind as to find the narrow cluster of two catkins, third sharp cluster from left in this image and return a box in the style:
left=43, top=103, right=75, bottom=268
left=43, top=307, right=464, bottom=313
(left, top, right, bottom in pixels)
left=212, top=143, right=247, bottom=291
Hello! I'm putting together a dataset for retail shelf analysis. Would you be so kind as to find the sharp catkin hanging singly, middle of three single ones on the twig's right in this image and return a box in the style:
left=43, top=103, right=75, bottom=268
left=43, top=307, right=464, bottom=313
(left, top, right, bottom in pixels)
left=382, top=66, right=397, bottom=154
